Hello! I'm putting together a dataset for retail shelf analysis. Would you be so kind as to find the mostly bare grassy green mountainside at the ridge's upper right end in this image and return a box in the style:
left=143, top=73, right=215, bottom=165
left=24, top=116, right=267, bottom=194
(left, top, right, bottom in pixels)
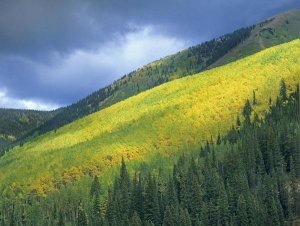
left=209, top=10, right=300, bottom=68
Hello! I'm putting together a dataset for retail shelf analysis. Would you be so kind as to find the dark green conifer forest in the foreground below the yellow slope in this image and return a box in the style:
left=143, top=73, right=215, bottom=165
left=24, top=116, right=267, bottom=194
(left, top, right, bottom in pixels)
left=1, top=82, right=300, bottom=226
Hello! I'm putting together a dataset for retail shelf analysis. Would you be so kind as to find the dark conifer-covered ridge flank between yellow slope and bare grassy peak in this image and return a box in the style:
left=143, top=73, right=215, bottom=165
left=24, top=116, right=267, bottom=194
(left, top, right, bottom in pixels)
left=22, top=27, right=253, bottom=139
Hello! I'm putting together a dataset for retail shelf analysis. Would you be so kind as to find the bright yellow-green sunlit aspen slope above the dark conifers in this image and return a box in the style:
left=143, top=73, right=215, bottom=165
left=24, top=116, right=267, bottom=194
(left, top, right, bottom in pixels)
left=0, top=39, right=300, bottom=194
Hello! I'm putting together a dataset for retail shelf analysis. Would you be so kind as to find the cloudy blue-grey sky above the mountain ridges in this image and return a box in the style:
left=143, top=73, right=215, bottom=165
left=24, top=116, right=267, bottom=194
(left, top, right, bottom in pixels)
left=0, top=0, right=300, bottom=109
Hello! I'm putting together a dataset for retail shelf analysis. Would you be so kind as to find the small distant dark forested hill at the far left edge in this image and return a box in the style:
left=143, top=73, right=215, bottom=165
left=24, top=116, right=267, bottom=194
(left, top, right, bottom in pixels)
left=0, top=109, right=56, bottom=150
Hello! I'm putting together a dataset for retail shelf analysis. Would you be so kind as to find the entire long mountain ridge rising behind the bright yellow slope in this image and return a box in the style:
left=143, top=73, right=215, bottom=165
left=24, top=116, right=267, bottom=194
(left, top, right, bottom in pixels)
left=16, top=10, right=300, bottom=146
